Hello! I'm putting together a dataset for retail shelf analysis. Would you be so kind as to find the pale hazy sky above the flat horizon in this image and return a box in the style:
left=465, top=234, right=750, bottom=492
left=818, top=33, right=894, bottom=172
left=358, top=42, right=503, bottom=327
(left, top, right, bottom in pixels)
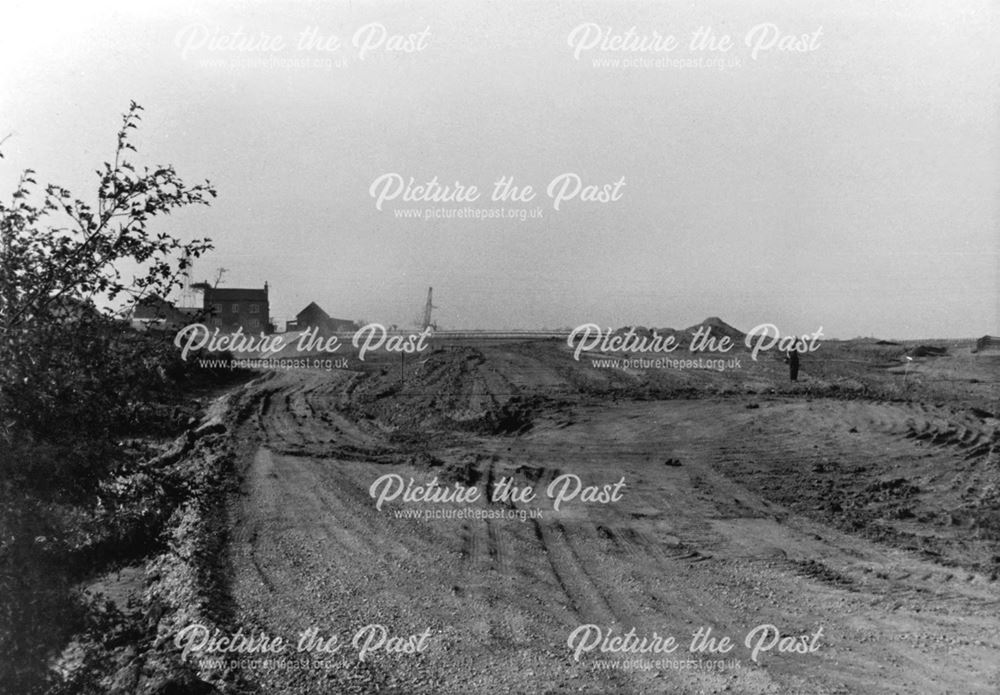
left=0, top=0, right=1000, bottom=338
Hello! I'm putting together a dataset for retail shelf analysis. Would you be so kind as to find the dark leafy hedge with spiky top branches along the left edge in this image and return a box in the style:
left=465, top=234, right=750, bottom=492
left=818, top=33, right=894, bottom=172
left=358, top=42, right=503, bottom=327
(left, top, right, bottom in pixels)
left=0, top=103, right=231, bottom=693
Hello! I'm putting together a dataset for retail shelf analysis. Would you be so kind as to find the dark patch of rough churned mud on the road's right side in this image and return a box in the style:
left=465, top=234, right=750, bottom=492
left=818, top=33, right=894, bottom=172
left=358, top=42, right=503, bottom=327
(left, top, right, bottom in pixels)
left=717, top=400, right=1000, bottom=581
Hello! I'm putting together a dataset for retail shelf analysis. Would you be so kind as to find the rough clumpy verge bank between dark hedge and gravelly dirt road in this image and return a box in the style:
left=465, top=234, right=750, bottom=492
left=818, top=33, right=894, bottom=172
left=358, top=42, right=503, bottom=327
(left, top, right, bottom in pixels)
left=50, top=383, right=266, bottom=695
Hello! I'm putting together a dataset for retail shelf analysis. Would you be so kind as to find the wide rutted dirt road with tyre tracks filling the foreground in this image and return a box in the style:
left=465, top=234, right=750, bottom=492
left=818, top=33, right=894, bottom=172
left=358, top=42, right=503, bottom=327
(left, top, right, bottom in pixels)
left=215, top=346, right=1000, bottom=693
